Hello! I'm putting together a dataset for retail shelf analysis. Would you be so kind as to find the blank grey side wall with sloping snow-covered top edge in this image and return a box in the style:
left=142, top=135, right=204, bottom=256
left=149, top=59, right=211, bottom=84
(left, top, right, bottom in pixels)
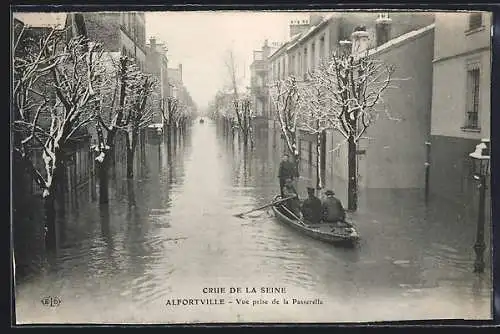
left=327, top=24, right=434, bottom=189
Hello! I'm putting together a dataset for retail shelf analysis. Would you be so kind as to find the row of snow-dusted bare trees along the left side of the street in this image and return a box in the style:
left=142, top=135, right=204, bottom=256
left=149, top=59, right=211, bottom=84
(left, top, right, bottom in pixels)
left=12, top=22, right=168, bottom=248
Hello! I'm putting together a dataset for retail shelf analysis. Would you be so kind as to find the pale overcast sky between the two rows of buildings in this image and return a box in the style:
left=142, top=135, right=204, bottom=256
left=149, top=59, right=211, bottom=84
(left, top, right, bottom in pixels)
left=146, top=11, right=308, bottom=109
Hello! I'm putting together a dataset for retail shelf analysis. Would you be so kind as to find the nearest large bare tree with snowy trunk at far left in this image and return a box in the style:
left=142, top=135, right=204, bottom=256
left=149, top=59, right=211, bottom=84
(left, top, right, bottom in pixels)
left=13, top=24, right=102, bottom=246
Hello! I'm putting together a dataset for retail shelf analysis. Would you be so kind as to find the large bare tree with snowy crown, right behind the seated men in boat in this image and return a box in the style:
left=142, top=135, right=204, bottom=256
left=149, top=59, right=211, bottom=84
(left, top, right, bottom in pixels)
left=313, top=51, right=395, bottom=210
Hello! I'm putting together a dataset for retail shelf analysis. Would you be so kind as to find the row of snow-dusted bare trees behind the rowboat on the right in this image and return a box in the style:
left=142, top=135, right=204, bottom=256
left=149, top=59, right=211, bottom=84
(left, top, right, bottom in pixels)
left=271, top=50, right=395, bottom=210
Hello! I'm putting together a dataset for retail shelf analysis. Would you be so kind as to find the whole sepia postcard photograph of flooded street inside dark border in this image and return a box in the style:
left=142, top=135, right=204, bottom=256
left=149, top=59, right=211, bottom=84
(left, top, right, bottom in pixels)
left=10, top=7, right=493, bottom=325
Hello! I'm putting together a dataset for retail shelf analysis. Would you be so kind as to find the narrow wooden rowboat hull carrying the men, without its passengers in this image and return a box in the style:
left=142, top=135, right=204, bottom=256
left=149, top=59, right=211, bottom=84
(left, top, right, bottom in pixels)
left=272, top=196, right=359, bottom=246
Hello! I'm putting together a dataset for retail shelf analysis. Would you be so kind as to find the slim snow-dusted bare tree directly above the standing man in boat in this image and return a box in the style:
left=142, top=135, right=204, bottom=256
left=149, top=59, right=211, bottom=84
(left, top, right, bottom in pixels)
left=270, top=76, right=300, bottom=165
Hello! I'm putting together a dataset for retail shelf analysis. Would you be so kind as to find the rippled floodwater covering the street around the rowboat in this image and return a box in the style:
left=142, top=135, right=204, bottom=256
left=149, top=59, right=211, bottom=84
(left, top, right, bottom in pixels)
left=16, top=120, right=491, bottom=324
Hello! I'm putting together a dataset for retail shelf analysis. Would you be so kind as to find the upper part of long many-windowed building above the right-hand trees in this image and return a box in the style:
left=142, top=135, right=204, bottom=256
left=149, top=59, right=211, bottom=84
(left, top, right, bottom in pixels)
left=269, top=12, right=434, bottom=85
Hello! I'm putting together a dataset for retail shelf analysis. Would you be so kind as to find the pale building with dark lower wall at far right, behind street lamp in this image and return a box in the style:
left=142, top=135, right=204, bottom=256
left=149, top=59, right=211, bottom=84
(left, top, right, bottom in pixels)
left=430, top=12, right=492, bottom=202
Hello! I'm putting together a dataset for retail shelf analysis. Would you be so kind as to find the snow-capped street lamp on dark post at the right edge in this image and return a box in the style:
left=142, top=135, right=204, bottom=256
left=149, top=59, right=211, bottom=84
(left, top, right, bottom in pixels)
left=469, top=139, right=490, bottom=273
